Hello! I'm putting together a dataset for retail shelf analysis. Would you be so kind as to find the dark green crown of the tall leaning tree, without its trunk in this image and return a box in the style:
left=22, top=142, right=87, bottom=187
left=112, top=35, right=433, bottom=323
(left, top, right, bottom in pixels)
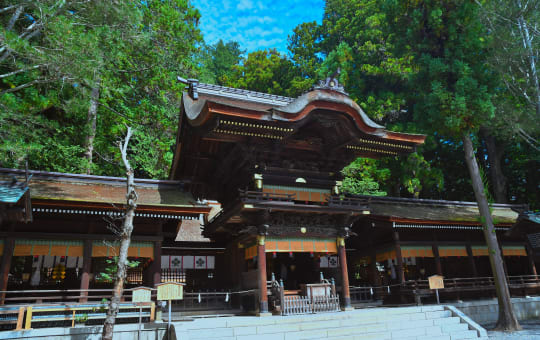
left=389, top=0, right=495, bottom=138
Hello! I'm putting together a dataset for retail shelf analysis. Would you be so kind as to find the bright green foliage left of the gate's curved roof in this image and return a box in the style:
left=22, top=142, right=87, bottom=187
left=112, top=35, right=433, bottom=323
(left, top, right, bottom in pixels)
left=0, top=0, right=201, bottom=178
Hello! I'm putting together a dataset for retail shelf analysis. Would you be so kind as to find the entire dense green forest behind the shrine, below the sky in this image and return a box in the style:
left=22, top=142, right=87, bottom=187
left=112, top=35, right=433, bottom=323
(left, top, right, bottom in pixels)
left=0, top=0, right=540, bottom=208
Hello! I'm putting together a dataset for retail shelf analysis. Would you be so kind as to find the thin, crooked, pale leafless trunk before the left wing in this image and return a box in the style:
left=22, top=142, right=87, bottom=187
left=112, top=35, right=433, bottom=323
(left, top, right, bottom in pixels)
left=102, top=127, right=137, bottom=340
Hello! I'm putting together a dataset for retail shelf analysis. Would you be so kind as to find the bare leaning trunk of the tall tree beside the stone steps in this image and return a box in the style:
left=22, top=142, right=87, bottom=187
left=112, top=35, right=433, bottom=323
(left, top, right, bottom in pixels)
left=463, top=133, right=521, bottom=331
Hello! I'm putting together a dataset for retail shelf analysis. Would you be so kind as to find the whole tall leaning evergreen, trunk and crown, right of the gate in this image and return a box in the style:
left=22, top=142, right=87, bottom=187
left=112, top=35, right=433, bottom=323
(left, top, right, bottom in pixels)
left=387, top=0, right=520, bottom=330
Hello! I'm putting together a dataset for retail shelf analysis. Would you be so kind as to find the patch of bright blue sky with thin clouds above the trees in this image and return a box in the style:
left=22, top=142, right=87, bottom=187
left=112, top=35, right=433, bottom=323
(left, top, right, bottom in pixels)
left=192, top=0, right=324, bottom=53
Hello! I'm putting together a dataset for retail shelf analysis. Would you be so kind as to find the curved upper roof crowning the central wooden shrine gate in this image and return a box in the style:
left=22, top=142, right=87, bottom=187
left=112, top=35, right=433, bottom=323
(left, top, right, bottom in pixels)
left=182, top=83, right=425, bottom=145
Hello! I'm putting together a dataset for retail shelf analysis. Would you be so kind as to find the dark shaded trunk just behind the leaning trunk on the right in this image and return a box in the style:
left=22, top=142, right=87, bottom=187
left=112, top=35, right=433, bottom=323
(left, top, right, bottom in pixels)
left=480, top=129, right=508, bottom=203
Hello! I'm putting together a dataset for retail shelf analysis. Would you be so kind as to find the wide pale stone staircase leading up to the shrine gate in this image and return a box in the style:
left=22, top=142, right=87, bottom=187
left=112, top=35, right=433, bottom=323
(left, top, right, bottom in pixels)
left=171, top=305, right=488, bottom=340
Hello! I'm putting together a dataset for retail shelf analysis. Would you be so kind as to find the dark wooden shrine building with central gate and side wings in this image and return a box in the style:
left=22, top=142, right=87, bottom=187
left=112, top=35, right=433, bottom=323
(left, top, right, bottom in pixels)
left=0, top=77, right=540, bottom=314
